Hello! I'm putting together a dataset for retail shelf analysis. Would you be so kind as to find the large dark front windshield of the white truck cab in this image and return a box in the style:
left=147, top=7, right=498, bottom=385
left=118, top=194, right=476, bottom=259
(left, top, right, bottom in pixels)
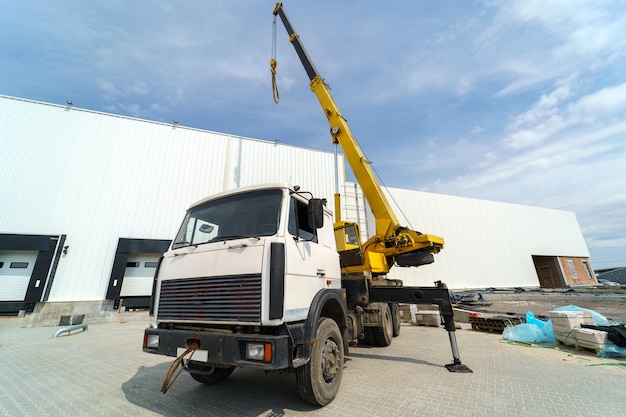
left=172, top=189, right=283, bottom=249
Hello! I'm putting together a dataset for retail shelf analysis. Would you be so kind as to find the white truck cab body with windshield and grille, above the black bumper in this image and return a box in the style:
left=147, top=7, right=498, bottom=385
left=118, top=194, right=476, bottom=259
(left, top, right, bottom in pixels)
left=154, top=184, right=341, bottom=326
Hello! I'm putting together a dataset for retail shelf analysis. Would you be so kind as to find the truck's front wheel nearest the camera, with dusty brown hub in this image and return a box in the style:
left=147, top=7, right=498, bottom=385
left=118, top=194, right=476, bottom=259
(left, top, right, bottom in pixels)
left=296, top=318, right=343, bottom=407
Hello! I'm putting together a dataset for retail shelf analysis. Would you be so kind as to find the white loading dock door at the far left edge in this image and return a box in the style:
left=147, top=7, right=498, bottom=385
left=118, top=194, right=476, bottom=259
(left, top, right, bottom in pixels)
left=0, top=251, right=39, bottom=302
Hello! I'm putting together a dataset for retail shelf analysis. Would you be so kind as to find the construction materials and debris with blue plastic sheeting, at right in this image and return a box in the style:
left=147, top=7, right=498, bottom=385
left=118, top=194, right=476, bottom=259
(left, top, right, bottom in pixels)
left=400, top=288, right=626, bottom=358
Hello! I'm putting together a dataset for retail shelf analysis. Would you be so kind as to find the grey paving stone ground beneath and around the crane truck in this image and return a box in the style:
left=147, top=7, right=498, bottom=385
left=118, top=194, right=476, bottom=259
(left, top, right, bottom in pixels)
left=0, top=319, right=626, bottom=417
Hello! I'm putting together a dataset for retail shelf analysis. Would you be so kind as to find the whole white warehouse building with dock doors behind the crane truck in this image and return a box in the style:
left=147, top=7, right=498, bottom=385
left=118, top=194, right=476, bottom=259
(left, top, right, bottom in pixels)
left=0, top=95, right=596, bottom=325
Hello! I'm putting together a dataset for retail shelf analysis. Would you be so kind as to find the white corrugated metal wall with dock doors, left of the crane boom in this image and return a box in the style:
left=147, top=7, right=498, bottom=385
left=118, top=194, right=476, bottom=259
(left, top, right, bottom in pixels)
left=0, top=96, right=343, bottom=301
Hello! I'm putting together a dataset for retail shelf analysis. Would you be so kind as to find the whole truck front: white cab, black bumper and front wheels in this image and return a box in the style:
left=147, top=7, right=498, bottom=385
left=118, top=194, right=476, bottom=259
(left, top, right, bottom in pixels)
left=144, top=184, right=348, bottom=405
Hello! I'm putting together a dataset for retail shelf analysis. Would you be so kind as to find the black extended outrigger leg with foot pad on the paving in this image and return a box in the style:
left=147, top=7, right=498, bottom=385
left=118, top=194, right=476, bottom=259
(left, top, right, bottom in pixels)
left=370, top=281, right=473, bottom=372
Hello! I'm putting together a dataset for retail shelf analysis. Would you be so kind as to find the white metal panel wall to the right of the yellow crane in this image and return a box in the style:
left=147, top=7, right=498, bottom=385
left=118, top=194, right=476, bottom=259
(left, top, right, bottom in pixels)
left=344, top=182, right=589, bottom=289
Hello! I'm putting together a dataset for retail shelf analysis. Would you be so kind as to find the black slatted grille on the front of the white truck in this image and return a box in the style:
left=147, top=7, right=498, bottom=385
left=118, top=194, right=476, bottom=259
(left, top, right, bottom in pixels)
left=158, top=274, right=261, bottom=323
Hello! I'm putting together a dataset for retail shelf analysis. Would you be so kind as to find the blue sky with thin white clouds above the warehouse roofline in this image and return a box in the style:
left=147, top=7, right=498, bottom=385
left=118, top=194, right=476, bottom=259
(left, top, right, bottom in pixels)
left=0, top=0, right=626, bottom=269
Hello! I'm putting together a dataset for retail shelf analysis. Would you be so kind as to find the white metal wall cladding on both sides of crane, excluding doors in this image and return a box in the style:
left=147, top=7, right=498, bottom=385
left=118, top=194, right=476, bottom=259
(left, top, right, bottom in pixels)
left=0, top=96, right=589, bottom=301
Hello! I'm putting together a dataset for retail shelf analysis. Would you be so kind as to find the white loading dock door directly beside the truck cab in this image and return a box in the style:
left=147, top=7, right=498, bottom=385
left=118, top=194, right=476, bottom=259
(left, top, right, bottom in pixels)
left=120, top=253, right=160, bottom=298
